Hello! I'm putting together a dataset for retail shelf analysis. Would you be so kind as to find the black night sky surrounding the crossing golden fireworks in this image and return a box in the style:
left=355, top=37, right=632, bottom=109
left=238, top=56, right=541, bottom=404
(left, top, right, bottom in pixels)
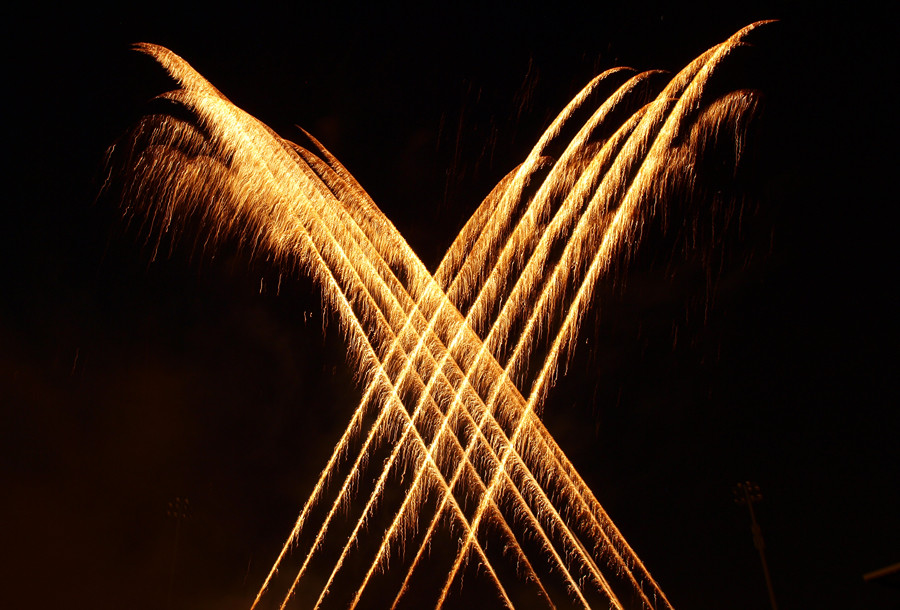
left=0, top=2, right=900, bottom=610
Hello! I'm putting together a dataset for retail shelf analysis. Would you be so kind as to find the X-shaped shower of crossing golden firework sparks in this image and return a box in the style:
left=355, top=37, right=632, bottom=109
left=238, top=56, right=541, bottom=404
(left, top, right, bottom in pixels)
left=113, top=23, right=762, bottom=609
